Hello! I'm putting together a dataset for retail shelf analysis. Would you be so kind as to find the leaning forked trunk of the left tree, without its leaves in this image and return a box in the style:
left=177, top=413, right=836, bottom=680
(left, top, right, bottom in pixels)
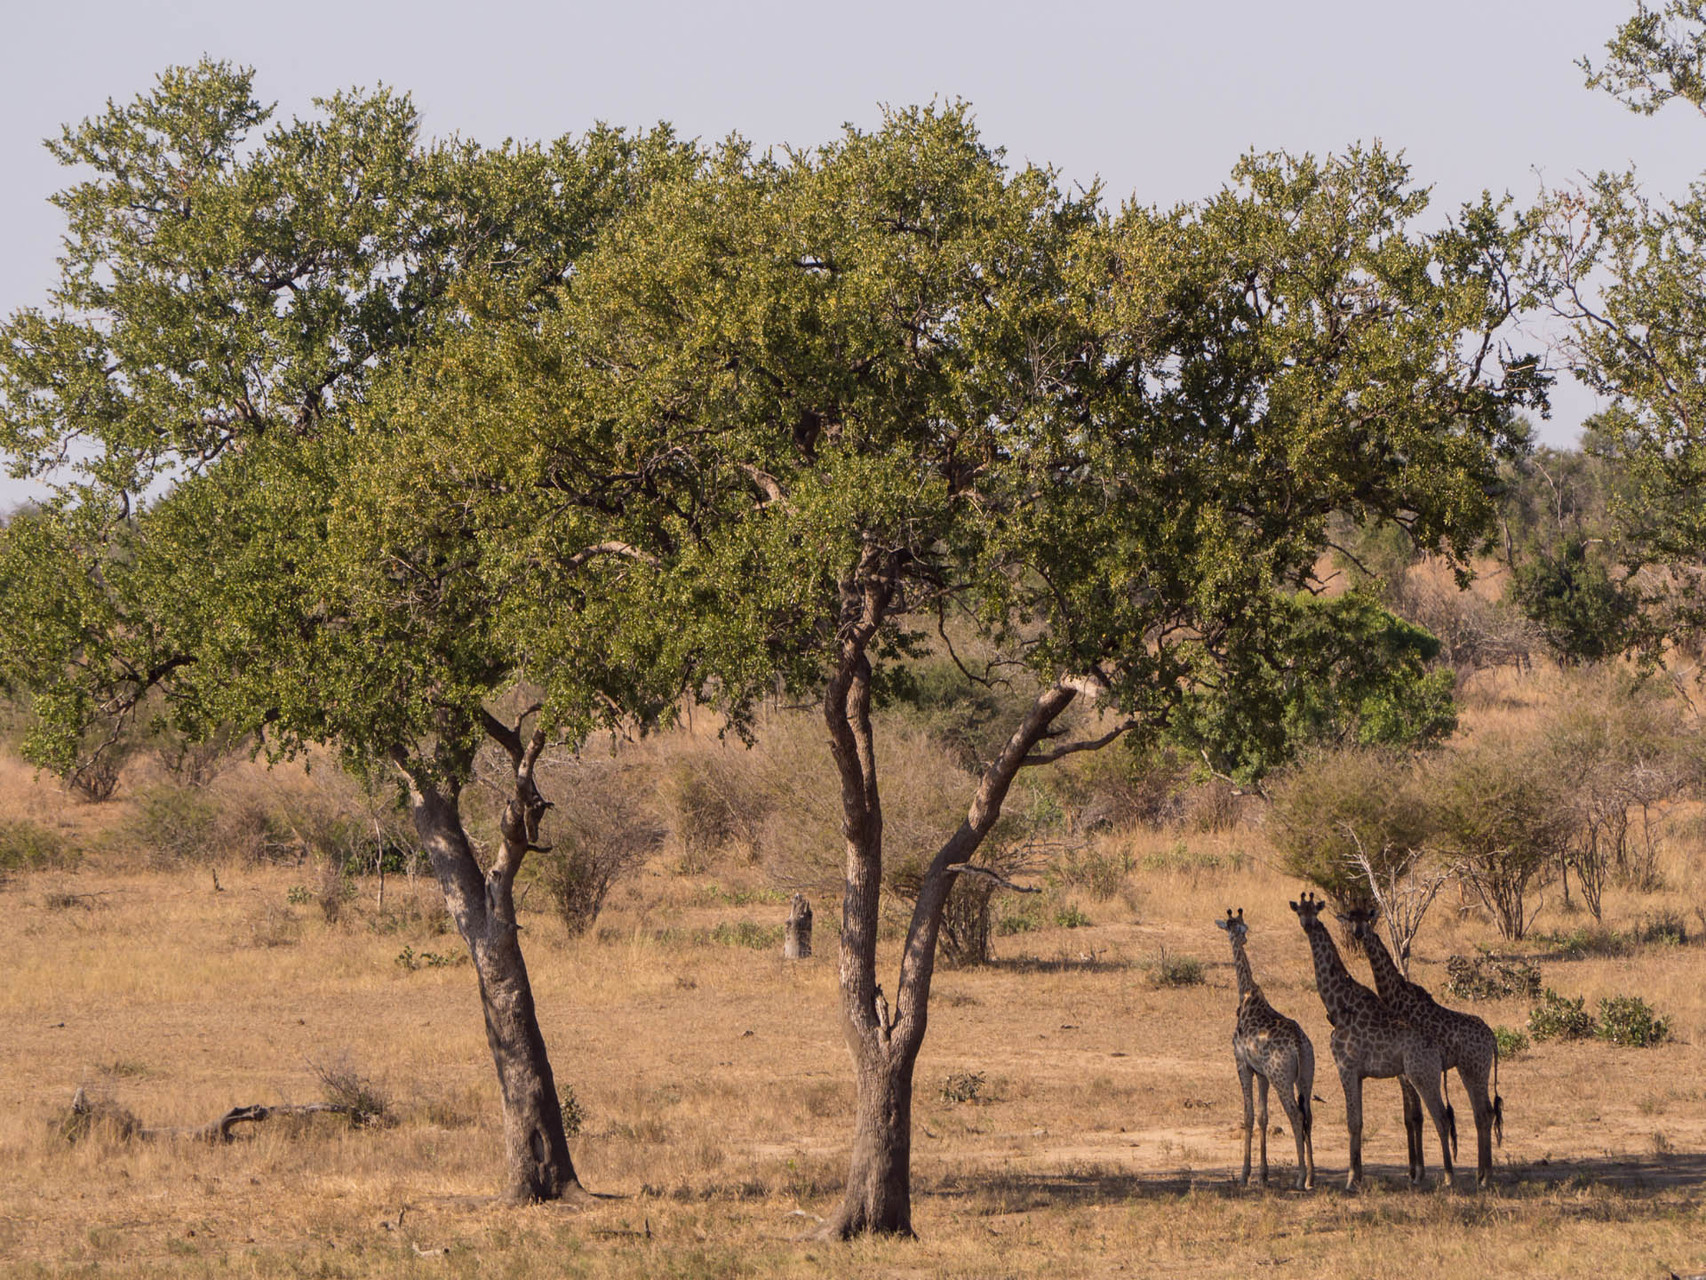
left=399, top=717, right=582, bottom=1201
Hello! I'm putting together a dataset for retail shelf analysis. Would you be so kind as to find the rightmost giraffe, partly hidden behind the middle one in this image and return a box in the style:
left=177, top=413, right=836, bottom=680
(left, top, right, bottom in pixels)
left=1341, top=908, right=1505, bottom=1186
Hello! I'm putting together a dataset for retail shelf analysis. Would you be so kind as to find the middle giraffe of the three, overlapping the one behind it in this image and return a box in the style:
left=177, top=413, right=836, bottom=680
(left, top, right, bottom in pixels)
left=1291, top=893, right=1452, bottom=1190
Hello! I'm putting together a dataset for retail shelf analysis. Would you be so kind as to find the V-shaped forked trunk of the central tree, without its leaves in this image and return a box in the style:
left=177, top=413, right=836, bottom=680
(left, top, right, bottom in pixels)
left=821, top=553, right=1112, bottom=1239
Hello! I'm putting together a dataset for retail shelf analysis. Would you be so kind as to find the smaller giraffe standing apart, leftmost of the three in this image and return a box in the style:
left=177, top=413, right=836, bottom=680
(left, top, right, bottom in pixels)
left=1215, top=906, right=1315, bottom=1191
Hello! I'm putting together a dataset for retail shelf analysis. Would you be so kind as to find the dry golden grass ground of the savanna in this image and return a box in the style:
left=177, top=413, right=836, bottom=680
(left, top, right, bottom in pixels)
left=0, top=674, right=1706, bottom=1277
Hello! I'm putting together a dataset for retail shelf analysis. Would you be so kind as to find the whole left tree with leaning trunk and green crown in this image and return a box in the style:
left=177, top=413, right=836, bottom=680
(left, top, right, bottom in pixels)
left=0, top=61, right=693, bottom=1198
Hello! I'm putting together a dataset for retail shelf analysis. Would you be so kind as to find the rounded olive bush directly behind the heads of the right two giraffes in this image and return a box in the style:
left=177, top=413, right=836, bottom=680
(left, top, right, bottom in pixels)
left=1269, top=748, right=1431, bottom=910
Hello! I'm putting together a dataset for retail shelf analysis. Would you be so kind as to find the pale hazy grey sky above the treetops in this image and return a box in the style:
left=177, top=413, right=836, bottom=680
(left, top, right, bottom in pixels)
left=0, top=0, right=1706, bottom=502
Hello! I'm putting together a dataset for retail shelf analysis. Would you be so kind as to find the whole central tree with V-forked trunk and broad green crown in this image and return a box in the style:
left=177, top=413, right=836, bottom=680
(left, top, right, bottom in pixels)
left=383, top=115, right=1544, bottom=1236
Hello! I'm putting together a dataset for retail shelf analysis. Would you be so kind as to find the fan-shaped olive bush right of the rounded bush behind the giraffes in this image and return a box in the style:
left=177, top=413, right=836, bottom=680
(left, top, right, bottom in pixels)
left=1426, top=736, right=1575, bottom=939
